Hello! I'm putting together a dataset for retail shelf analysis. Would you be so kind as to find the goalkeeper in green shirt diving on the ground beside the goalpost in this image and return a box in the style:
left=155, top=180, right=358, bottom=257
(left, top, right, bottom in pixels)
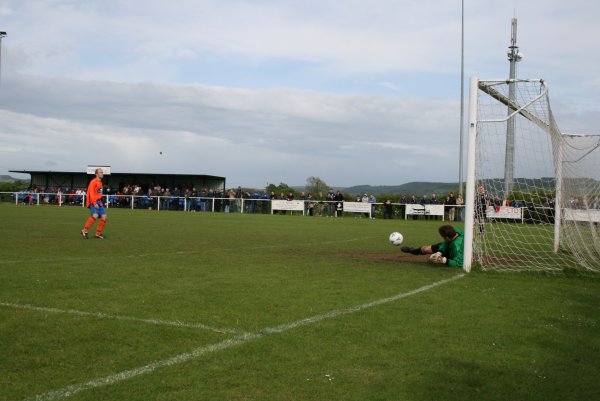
left=402, top=226, right=464, bottom=267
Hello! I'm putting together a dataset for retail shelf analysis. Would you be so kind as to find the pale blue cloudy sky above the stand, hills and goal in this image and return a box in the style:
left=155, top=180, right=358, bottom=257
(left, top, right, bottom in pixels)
left=0, top=0, right=600, bottom=188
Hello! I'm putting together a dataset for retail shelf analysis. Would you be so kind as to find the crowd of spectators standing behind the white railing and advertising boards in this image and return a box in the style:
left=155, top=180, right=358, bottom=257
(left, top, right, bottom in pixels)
left=10, top=184, right=600, bottom=222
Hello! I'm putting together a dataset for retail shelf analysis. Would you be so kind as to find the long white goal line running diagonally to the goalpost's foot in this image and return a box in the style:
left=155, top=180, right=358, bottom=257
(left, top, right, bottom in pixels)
left=27, top=274, right=464, bottom=401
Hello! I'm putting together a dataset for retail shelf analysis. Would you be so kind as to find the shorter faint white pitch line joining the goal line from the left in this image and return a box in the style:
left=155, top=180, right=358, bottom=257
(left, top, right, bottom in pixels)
left=0, top=302, right=243, bottom=334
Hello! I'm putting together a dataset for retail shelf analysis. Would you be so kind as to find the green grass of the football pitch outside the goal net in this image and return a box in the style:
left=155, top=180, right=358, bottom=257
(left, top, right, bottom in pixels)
left=0, top=205, right=600, bottom=401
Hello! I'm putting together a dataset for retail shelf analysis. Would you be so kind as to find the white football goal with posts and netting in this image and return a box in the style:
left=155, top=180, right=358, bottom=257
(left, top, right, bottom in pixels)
left=465, top=78, right=600, bottom=272
